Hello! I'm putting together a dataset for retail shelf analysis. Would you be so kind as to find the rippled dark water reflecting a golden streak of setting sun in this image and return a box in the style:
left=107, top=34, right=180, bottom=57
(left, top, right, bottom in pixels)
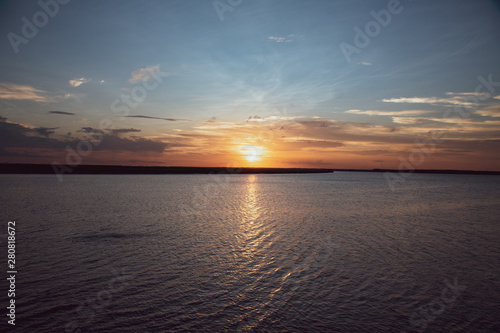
left=0, top=172, right=500, bottom=332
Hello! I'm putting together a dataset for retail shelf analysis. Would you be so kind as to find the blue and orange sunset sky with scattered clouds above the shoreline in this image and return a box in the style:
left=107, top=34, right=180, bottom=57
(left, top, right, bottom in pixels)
left=0, top=0, right=500, bottom=171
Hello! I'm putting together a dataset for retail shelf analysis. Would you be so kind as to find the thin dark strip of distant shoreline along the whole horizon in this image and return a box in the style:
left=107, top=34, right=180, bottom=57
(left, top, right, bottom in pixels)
left=0, top=163, right=500, bottom=175
